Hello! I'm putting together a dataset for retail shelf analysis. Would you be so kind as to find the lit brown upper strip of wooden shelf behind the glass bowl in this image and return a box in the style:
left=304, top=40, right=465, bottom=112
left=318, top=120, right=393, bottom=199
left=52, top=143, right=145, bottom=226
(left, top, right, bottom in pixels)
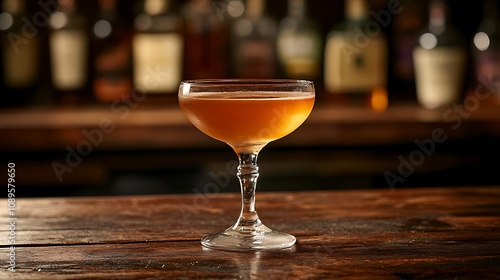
left=0, top=102, right=500, bottom=151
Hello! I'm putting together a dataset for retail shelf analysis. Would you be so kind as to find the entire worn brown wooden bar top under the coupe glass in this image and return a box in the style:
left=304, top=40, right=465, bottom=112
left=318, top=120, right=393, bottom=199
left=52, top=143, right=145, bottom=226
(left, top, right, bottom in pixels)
left=0, top=186, right=500, bottom=279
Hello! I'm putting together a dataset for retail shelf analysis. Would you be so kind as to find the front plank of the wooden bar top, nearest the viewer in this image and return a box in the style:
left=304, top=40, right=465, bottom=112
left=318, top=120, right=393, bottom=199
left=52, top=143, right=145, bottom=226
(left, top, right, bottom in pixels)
left=0, top=235, right=500, bottom=279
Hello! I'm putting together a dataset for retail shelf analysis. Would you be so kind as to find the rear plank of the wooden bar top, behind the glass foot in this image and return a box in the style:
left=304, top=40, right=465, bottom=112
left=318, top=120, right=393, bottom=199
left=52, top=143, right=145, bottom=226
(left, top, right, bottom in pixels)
left=0, top=187, right=500, bottom=246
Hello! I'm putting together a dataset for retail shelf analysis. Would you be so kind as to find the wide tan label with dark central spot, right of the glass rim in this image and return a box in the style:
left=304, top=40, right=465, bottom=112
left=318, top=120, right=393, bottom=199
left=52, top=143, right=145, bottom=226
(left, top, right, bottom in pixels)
left=324, top=34, right=387, bottom=93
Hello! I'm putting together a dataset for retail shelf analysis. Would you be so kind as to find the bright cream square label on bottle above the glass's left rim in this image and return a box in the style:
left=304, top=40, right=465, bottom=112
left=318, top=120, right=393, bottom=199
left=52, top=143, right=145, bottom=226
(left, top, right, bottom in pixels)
left=133, top=34, right=183, bottom=93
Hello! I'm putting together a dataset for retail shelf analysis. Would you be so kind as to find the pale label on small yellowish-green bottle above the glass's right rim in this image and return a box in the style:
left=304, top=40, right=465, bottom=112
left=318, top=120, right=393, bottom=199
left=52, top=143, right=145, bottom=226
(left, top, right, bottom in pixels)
left=278, top=33, right=320, bottom=78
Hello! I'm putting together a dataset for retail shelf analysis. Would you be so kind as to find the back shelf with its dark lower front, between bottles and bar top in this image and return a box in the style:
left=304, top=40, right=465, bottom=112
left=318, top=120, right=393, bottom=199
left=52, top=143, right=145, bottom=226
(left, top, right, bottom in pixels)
left=0, top=101, right=500, bottom=196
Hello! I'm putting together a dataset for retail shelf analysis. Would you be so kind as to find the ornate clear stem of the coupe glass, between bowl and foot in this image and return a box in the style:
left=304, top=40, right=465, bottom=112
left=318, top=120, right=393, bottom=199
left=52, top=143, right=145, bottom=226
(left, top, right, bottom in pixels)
left=233, top=152, right=262, bottom=233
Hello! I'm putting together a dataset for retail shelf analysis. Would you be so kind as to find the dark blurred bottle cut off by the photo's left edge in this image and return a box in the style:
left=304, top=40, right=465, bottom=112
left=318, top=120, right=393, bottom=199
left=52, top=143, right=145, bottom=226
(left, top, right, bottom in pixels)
left=0, top=0, right=40, bottom=106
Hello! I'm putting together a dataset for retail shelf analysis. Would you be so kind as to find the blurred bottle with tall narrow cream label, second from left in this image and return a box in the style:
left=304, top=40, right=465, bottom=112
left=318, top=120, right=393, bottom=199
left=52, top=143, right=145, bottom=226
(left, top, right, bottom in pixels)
left=49, top=0, right=91, bottom=104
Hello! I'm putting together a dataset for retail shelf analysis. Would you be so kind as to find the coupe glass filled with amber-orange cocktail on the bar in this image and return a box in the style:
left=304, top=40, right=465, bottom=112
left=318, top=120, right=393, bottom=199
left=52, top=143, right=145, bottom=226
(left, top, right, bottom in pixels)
left=179, top=79, right=315, bottom=250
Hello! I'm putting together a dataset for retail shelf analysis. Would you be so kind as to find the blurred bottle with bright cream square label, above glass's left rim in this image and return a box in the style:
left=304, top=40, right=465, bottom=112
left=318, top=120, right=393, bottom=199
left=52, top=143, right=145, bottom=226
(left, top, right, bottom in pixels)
left=132, top=0, right=184, bottom=98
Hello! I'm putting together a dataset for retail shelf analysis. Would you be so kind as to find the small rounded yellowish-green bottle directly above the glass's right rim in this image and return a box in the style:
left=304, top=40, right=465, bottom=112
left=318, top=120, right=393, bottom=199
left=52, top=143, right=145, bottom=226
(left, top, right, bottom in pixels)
left=277, top=0, right=322, bottom=80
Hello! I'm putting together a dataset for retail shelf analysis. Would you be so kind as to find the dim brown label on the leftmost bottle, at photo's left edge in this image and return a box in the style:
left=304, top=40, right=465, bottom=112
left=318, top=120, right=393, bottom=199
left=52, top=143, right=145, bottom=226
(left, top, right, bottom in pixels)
left=2, top=37, right=40, bottom=88
